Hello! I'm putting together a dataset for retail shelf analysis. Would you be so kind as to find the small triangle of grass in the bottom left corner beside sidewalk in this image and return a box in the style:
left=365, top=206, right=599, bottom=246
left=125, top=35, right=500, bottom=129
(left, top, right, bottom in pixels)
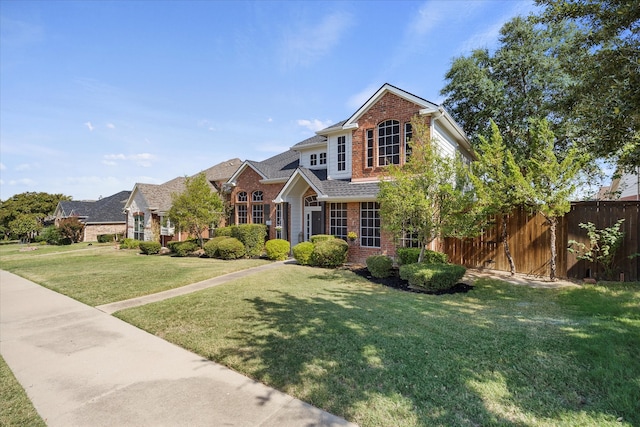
left=0, top=357, right=45, bottom=426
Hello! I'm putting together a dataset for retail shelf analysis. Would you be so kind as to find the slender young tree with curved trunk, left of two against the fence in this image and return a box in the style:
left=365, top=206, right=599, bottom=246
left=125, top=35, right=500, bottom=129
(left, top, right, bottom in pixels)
left=471, top=121, right=528, bottom=275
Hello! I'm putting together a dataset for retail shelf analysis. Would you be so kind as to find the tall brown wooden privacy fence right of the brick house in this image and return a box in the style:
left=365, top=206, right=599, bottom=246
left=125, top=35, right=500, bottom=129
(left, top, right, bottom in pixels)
left=441, top=201, right=640, bottom=281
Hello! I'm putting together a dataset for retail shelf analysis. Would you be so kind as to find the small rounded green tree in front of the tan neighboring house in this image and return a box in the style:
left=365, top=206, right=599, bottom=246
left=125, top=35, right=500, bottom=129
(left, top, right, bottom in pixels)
left=169, top=173, right=224, bottom=247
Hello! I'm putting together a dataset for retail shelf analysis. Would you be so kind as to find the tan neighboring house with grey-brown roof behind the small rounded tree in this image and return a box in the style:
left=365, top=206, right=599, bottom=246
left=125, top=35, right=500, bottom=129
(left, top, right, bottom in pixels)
left=124, top=159, right=242, bottom=246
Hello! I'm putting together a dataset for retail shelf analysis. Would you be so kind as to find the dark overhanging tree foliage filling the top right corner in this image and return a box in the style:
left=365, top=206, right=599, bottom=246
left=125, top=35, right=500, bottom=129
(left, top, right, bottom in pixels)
left=536, top=0, right=640, bottom=170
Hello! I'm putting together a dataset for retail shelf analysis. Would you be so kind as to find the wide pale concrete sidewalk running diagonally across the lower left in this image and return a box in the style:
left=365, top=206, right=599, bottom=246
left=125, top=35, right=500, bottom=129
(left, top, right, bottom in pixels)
left=0, top=271, right=354, bottom=427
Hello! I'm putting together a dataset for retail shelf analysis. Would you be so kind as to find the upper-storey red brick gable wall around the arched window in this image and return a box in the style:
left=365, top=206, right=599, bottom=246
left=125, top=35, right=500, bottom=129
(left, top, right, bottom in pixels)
left=351, top=92, right=430, bottom=179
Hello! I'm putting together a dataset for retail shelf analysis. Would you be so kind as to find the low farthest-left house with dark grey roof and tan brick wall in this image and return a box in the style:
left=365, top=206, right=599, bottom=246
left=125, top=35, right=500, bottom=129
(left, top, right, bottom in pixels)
left=53, top=191, right=131, bottom=242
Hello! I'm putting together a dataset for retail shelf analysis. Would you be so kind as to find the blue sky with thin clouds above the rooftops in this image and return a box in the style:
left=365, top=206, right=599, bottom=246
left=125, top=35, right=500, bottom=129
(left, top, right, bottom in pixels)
left=0, top=0, right=535, bottom=200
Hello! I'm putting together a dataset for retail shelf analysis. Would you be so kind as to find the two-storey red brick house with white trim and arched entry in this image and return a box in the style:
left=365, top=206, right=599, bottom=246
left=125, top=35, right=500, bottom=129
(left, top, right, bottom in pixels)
left=225, top=84, right=472, bottom=262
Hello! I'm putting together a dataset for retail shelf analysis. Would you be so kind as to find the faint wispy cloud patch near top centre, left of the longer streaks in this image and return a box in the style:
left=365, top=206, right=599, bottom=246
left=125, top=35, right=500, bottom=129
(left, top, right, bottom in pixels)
left=283, top=12, right=352, bottom=67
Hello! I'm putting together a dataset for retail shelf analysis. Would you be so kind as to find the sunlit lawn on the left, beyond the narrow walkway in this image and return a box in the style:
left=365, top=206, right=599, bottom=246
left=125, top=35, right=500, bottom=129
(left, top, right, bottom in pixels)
left=0, top=244, right=269, bottom=306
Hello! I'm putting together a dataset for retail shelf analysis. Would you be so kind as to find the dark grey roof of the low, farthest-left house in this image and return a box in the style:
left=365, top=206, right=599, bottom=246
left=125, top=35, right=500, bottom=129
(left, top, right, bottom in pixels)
left=56, top=191, right=131, bottom=224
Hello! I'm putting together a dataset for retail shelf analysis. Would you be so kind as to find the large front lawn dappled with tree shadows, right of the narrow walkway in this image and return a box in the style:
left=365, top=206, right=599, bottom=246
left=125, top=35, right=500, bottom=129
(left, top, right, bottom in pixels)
left=117, top=265, right=640, bottom=427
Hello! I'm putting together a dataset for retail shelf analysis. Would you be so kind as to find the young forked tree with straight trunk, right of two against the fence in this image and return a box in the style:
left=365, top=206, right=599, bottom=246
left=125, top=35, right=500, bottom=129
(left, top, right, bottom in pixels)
left=525, top=120, right=585, bottom=280
